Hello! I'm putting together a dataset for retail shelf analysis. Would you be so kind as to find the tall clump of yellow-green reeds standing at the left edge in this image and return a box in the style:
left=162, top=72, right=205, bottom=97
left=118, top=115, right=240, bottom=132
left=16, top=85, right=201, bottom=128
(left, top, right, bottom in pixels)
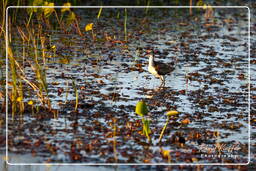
left=3, top=0, right=87, bottom=118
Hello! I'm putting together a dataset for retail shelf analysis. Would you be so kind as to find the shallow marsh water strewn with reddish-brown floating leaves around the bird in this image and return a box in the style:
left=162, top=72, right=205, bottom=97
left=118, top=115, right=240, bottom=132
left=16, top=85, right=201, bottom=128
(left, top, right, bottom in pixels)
left=0, top=8, right=255, bottom=167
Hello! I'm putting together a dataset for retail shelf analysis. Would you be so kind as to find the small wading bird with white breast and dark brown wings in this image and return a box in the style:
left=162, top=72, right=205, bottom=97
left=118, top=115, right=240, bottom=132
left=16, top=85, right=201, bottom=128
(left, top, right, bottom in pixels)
left=148, top=54, right=175, bottom=87
